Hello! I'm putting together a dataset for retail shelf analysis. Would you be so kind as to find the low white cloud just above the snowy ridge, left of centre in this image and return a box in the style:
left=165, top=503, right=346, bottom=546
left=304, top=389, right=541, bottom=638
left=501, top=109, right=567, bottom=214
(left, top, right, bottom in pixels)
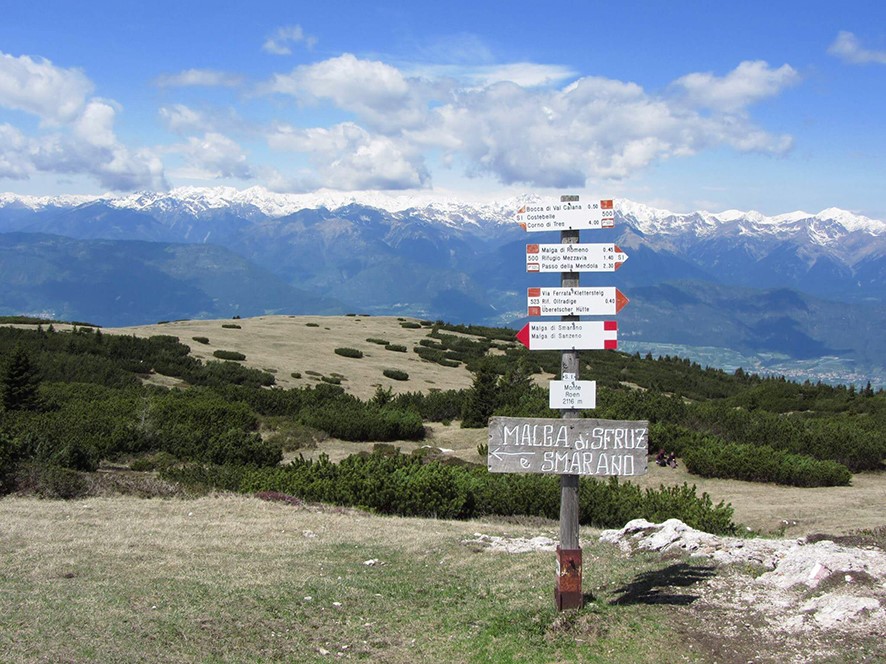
left=268, top=122, right=428, bottom=191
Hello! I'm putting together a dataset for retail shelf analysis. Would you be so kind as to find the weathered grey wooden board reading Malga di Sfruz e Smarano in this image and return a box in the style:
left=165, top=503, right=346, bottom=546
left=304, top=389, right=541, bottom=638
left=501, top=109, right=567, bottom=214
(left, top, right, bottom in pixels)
left=486, top=417, right=649, bottom=476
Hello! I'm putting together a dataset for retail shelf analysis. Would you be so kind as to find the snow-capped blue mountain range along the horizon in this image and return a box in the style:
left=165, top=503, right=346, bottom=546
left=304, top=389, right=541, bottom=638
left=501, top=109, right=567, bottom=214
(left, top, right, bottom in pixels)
left=0, top=187, right=886, bottom=384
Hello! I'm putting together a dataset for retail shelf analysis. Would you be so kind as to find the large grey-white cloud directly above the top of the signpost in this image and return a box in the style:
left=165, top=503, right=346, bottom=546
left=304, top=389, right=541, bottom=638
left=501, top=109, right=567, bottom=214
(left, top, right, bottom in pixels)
left=416, top=70, right=791, bottom=187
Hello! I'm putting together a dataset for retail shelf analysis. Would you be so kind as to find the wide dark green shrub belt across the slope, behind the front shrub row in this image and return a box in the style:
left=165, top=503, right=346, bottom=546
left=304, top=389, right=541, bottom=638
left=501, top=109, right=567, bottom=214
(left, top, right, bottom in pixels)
left=0, top=323, right=886, bottom=500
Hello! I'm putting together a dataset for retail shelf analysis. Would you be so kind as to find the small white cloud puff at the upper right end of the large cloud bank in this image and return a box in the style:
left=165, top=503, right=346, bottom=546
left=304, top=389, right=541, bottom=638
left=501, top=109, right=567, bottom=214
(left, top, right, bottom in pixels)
left=673, top=60, right=800, bottom=112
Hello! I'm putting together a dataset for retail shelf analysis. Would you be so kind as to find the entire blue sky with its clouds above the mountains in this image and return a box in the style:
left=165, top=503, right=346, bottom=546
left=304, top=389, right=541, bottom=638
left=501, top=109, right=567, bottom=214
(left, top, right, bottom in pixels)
left=0, top=0, right=886, bottom=219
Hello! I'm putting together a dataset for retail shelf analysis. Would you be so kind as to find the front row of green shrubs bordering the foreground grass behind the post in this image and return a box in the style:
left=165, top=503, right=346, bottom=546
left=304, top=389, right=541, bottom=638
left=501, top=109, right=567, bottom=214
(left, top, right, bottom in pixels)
left=162, top=446, right=735, bottom=534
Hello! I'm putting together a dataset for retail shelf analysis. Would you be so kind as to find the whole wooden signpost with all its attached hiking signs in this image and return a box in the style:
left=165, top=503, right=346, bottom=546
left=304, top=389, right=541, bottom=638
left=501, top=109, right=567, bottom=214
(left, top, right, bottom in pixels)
left=487, top=195, right=649, bottom=610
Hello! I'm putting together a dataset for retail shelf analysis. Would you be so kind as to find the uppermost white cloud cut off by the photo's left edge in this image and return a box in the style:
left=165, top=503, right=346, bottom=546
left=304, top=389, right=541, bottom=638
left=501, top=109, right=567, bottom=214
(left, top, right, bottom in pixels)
left=0, top=52, right=93, bottom=124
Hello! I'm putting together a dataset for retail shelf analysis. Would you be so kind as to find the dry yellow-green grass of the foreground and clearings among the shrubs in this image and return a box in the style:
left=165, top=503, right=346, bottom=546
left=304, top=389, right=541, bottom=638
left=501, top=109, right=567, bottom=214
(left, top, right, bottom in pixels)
left=0, top=316, right=886, bottom=664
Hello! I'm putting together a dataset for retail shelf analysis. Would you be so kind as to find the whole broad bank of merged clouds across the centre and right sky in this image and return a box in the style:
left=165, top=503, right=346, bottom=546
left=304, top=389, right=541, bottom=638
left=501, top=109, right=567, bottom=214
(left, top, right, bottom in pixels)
left=265, top=54, right=799, bottom=188
